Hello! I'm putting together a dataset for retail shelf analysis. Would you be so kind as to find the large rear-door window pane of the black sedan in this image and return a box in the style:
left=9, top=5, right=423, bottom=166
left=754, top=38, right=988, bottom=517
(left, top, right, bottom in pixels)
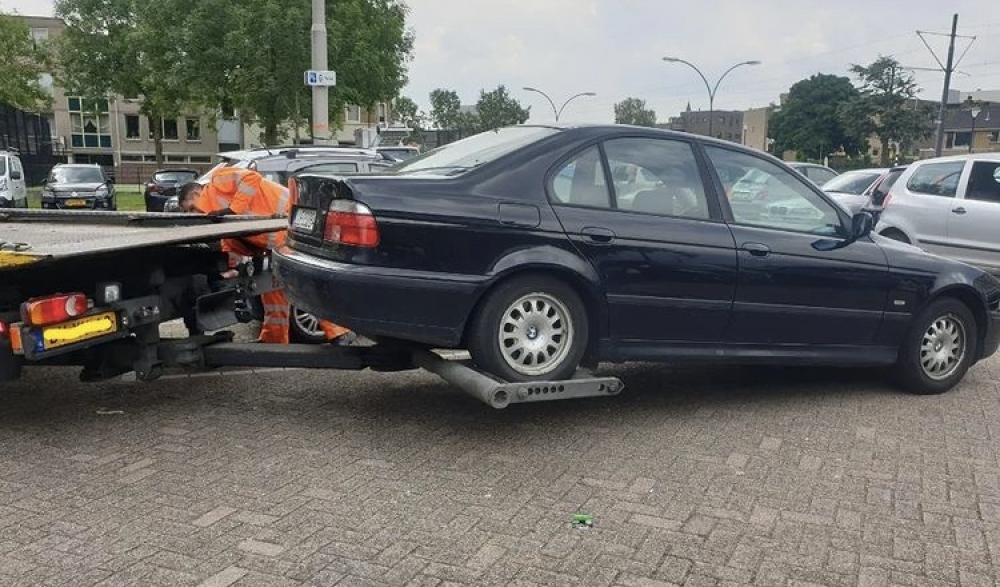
left=604, top=138, right=709, bottom=219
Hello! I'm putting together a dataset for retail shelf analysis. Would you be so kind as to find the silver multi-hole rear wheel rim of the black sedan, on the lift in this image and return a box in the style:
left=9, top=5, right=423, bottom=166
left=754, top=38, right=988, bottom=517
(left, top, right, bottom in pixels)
left=498, top=292, right=575, bottom=377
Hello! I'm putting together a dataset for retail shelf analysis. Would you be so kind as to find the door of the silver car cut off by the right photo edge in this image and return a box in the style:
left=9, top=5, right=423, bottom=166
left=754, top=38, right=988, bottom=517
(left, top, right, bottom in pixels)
left=948, top=160, right=1000, bottom=269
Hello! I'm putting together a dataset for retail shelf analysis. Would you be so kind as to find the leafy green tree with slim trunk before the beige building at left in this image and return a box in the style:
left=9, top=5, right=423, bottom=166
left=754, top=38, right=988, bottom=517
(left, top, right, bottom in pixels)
left=55, top=0, right=197, bottom=164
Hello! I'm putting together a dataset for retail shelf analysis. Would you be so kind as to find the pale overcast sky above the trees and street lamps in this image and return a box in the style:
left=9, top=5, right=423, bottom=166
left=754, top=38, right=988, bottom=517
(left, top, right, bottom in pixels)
left=0, top=0, right=1000, bottom=122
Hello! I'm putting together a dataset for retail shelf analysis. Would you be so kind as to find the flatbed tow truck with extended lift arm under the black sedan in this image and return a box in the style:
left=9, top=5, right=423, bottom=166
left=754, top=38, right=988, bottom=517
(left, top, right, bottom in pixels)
left=0, top=210, right=623, bottom=409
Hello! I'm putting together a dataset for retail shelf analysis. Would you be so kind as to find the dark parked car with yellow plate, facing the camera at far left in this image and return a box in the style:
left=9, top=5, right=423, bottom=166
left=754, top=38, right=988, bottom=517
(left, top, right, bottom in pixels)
left=42, top=163, right=118, bottom=210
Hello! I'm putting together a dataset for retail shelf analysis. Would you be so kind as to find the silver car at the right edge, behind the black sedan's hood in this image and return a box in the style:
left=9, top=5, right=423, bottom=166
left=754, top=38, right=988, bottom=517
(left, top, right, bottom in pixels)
left=877, top=153, right=1000, bottom=272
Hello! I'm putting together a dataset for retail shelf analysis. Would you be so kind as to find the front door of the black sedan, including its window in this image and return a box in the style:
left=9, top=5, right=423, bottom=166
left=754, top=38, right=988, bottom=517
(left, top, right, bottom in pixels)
left=705, top=146, right=888, bottom=345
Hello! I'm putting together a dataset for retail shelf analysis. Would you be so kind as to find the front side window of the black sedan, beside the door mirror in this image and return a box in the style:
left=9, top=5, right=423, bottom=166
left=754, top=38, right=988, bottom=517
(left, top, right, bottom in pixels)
left=705, top=146, right=843, bottom=236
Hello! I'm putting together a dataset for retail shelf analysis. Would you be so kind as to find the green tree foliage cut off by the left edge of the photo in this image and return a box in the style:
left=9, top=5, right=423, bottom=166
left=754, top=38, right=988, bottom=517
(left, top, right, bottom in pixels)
left=0, top=13, right=51, bottom=111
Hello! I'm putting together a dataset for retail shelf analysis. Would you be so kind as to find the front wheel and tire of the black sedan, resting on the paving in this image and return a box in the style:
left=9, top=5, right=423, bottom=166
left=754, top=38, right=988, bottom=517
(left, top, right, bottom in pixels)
left=896, top=298, right=979, bottom=395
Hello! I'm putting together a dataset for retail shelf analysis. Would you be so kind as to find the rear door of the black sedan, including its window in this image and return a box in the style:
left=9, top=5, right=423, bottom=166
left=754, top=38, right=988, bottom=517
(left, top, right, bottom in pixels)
left=549, top=137, right=736, bottom=344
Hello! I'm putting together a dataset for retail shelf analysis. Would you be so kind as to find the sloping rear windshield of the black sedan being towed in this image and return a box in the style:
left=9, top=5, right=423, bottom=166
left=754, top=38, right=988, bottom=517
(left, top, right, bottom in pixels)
left=392, top=126, right=559, bottom=175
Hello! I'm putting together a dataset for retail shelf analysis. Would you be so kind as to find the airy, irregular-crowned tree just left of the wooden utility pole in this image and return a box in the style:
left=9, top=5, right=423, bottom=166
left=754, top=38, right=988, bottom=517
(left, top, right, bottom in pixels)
left=841, top=57, right=933, bottom=167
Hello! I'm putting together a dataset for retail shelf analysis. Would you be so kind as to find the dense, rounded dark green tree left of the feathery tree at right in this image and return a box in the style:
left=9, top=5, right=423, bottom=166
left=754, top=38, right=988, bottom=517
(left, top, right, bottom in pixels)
left=769, top=74, right=865, bottom=159
